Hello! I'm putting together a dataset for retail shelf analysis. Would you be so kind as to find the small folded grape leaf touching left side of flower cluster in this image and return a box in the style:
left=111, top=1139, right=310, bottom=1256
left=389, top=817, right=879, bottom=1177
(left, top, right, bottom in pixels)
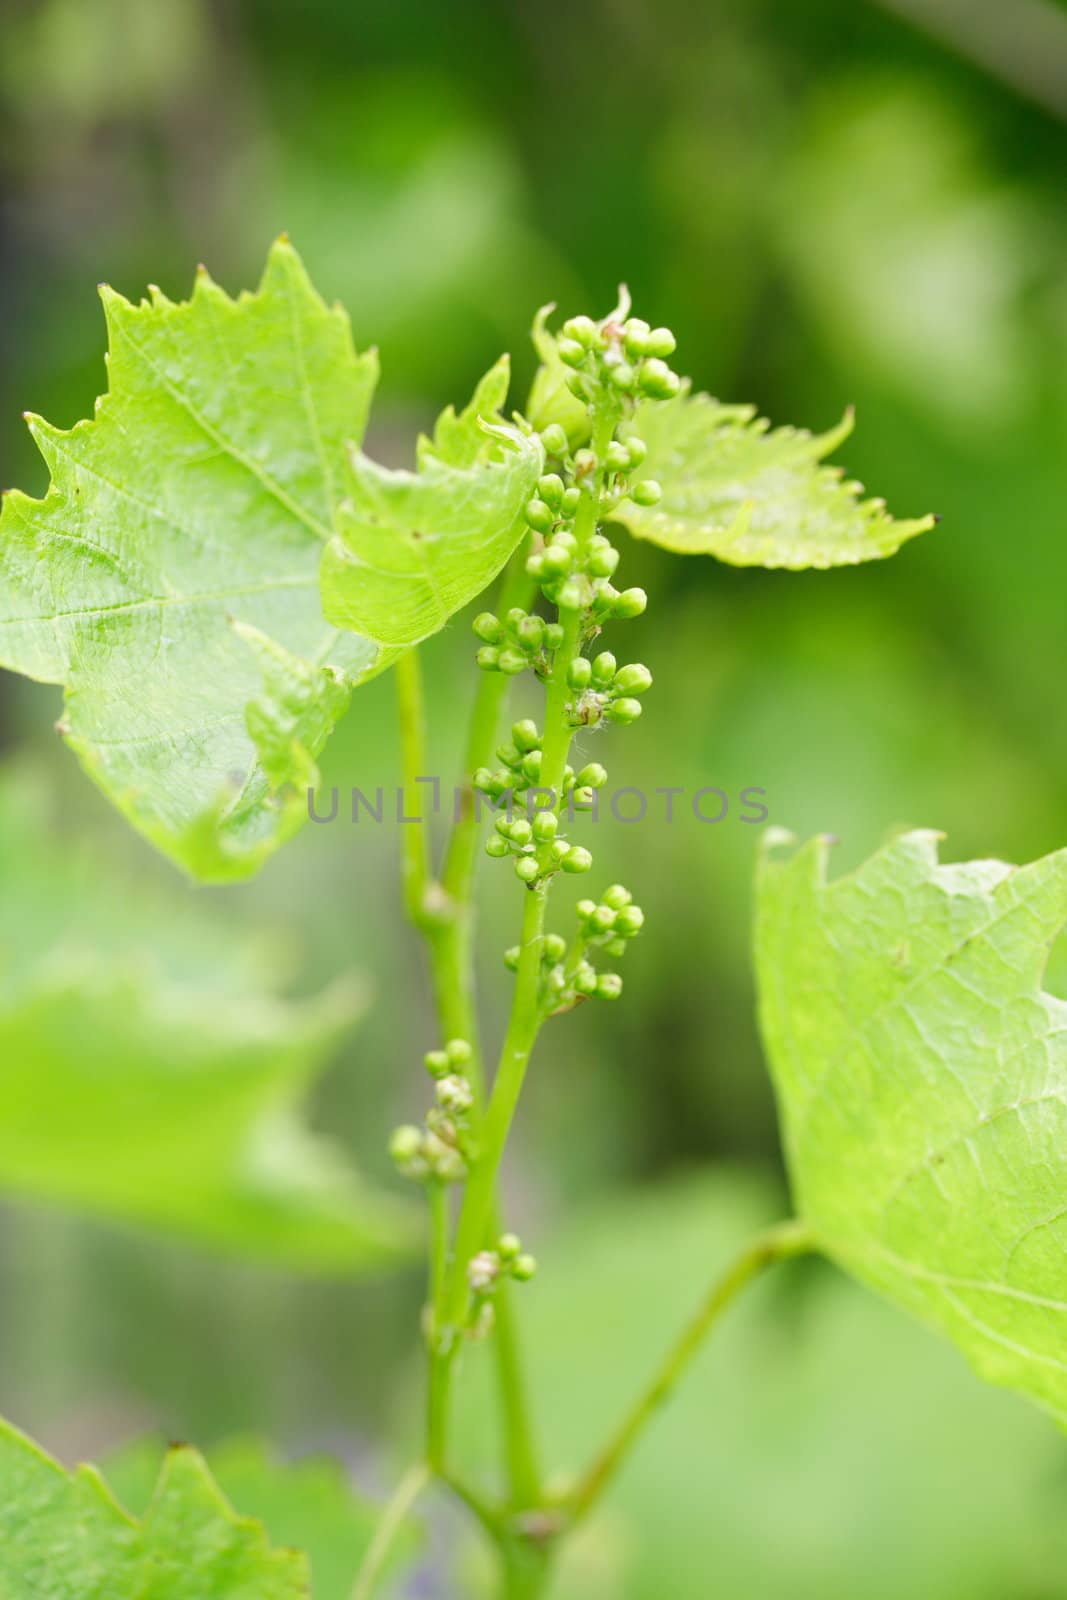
left=322, top=363, right=544, bottom=646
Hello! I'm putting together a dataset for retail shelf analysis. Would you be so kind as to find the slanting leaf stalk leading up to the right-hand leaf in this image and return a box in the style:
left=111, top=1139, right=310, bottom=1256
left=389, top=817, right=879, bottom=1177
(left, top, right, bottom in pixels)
left=565, top=1222, right=816, bottom=1525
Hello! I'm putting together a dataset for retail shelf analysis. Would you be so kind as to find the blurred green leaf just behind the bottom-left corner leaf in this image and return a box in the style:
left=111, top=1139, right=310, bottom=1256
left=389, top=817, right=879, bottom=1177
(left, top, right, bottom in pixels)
left=102, top=1438, right=413, bottom=1600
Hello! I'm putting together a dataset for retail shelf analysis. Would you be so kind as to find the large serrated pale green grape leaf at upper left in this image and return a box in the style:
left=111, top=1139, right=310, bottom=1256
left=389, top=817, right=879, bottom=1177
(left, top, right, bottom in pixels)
left=0, top=240, right=392, bottom=880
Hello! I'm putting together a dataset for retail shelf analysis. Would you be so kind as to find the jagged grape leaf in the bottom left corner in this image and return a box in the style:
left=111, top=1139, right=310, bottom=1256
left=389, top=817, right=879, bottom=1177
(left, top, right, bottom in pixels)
left=0, top=1422, right=310, bottom=1600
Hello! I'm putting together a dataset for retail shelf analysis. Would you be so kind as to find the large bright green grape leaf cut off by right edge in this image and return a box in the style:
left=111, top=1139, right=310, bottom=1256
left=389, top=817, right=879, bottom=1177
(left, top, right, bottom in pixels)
left=757, top=832, right=1067, bottom=1422
